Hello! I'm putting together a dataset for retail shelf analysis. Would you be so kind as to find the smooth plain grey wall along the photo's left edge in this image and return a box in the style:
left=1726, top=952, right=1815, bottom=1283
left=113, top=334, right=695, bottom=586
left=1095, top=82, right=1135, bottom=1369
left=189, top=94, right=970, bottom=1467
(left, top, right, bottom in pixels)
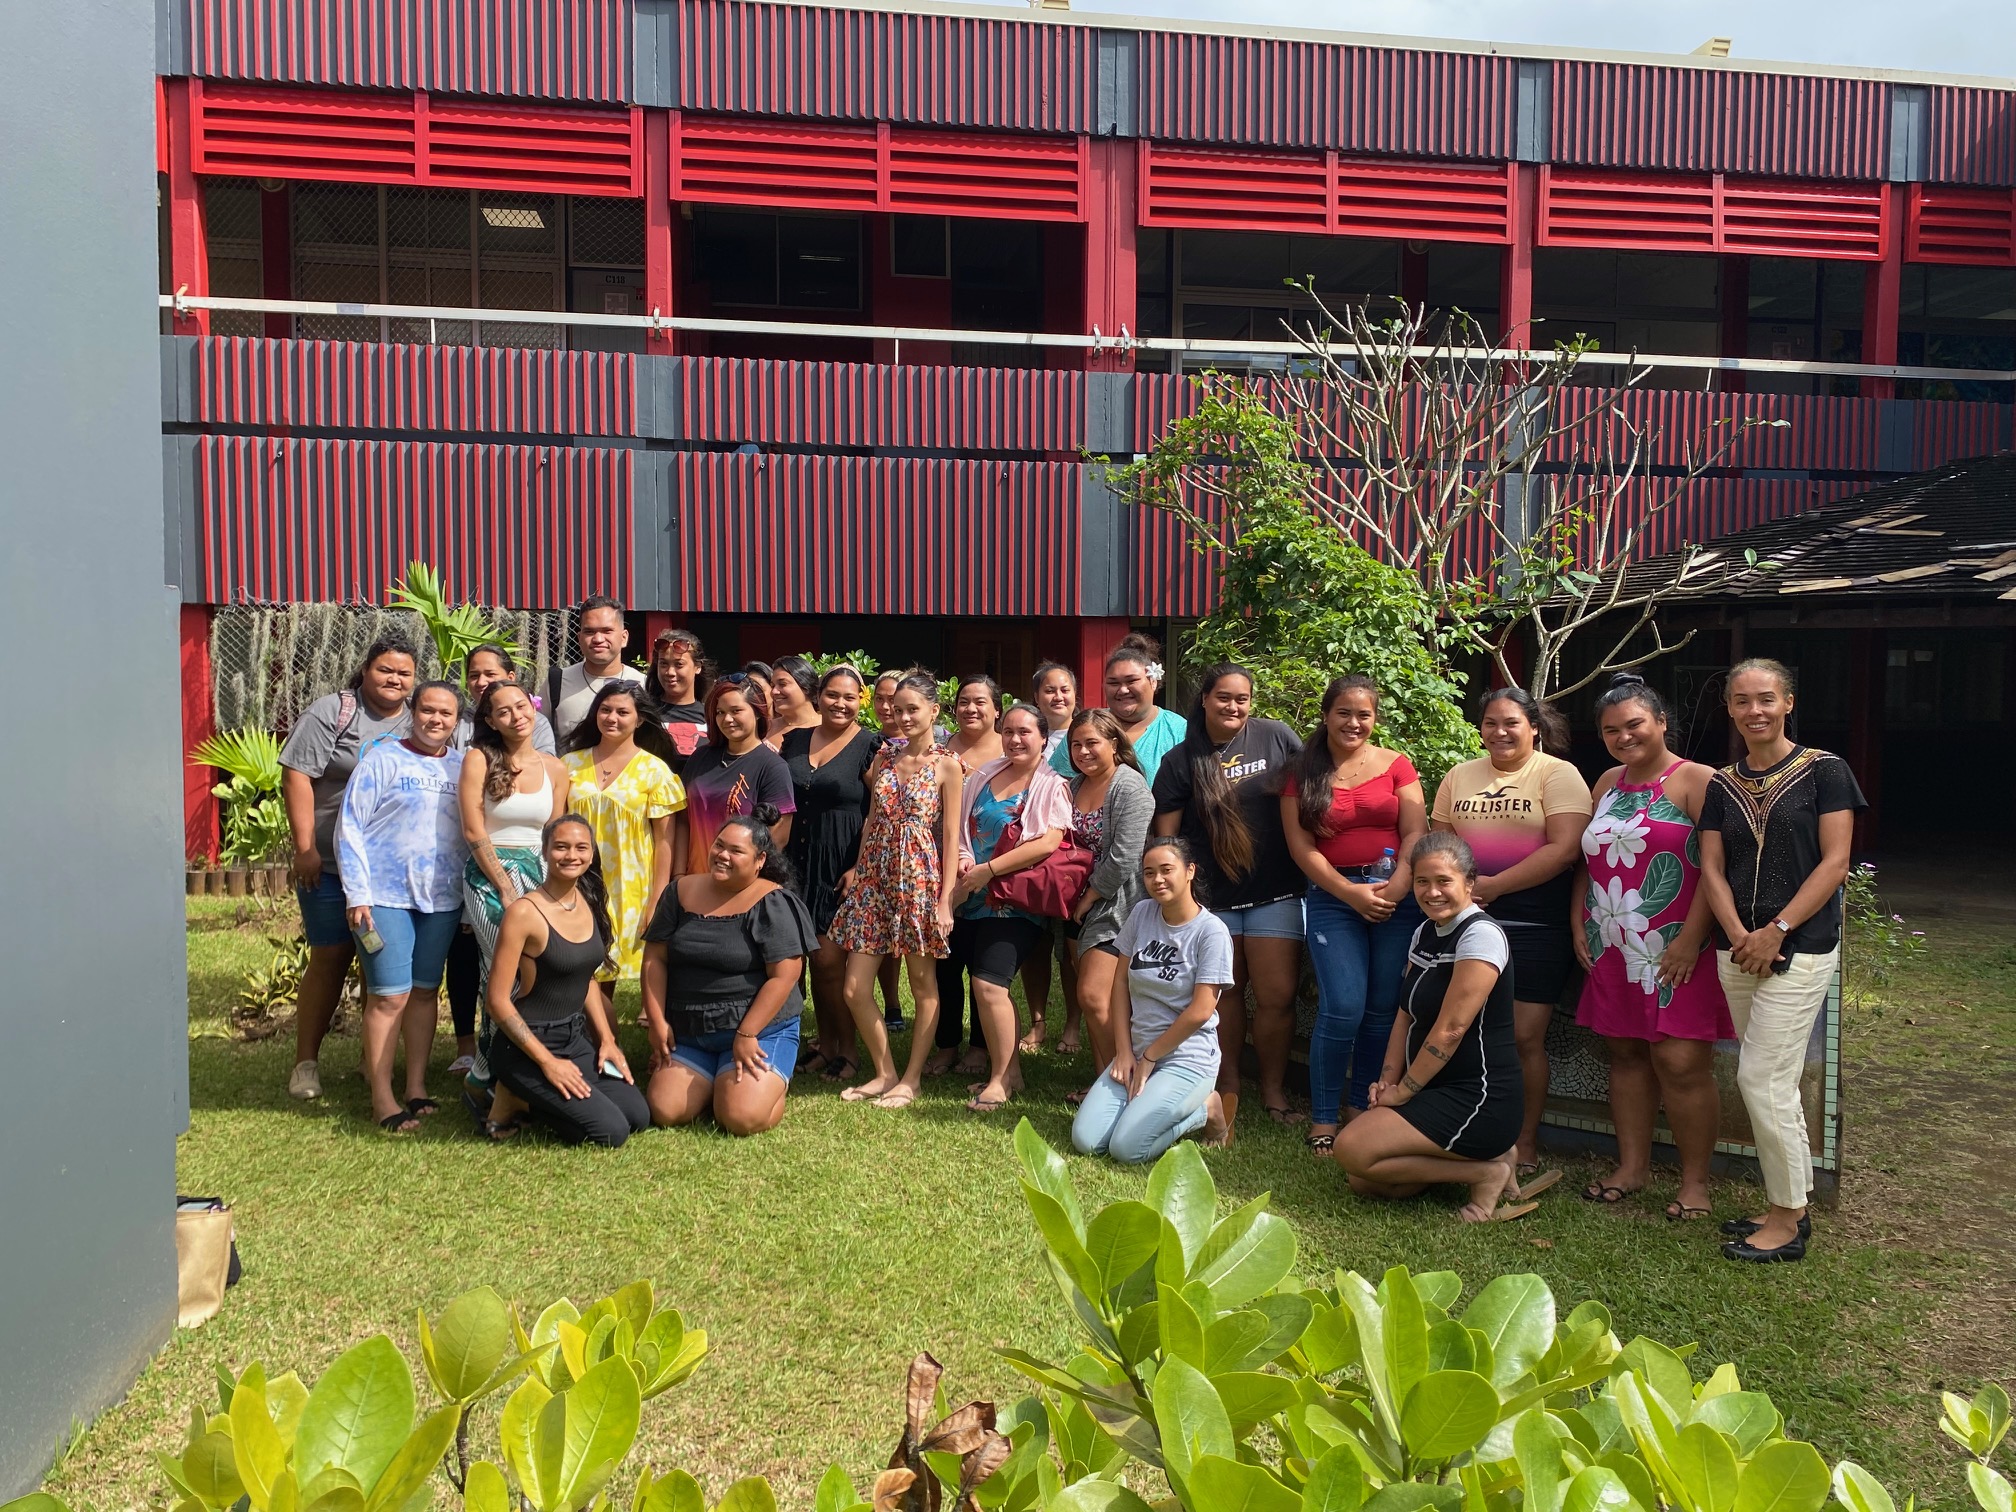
left=0, top=0, right=190, bottom=1500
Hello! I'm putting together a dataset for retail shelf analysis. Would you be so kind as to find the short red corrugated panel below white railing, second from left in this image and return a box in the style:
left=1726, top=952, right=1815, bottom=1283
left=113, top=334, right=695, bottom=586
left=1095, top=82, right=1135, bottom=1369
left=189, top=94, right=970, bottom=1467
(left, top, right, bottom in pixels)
left=675, top=357, right=1085, bottom=452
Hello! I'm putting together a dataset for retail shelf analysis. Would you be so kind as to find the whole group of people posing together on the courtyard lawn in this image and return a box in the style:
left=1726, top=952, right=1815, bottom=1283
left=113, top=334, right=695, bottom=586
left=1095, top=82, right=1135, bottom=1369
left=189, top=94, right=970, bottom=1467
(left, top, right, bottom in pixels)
left=282, top=599, right=1863, bottom=1260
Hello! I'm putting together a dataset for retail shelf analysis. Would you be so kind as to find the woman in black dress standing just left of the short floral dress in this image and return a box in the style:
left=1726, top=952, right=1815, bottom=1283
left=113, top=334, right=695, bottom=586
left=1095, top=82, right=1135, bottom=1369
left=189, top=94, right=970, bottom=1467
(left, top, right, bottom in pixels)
left=782, top=667, right=883, bottom=1081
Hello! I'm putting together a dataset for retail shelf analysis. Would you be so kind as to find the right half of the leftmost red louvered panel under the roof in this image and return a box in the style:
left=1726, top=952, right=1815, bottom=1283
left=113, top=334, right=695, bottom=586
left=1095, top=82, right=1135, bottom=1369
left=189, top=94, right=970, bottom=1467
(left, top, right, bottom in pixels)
left=421, top=97, right=643, bottom=198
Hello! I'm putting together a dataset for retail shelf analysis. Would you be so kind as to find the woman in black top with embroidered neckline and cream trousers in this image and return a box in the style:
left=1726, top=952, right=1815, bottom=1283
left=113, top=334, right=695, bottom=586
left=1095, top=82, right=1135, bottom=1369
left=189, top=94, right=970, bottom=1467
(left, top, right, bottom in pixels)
left=1697, top=657, right=1867, bottom=1262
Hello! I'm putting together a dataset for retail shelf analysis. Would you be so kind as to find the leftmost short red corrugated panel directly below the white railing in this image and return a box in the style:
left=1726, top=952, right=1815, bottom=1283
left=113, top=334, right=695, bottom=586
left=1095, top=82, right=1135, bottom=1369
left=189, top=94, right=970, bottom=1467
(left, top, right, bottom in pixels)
left=194, top=337, right=637, bottom=435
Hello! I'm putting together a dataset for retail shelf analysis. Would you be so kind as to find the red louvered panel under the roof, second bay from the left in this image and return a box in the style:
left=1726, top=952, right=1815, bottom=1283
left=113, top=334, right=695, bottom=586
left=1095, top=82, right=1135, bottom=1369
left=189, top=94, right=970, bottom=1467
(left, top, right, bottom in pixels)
left=669, top=111, right=1085, bottom=220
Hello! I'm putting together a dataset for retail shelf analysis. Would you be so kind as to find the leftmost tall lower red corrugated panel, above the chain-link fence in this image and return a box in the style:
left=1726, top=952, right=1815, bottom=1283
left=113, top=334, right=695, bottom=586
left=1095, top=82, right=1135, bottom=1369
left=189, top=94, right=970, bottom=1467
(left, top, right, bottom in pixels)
left=196, top=435, right=635, bottom=609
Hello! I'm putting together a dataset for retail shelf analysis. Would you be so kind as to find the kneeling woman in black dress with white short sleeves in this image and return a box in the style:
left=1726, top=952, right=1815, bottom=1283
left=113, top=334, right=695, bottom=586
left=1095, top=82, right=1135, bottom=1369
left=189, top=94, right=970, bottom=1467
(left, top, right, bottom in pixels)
left=1337, top=831, right=1540, bottom=1224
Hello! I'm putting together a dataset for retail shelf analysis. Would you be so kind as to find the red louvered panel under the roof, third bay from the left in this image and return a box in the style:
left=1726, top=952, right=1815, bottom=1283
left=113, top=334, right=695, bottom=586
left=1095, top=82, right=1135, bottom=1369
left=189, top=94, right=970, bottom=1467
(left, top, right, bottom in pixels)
left=1141, top=141, right=1512, bottom=242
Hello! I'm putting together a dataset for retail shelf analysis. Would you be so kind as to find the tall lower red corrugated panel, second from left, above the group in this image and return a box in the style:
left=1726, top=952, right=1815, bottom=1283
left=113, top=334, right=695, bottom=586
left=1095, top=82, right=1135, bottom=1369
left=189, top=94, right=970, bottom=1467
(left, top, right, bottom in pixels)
left=673, top=452, right=1083, bottom=615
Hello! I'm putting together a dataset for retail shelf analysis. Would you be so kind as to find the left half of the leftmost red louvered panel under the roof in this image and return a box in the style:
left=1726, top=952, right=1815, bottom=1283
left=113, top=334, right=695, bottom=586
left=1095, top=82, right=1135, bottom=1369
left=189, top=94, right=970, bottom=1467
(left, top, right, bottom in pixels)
left=190, top=79, right=419, bottom=183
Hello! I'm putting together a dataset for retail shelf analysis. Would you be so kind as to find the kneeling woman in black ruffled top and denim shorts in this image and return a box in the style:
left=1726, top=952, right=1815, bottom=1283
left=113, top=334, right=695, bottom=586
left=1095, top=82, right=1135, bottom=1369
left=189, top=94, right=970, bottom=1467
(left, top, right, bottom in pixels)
left=643, top=806, right=818, bottom=1135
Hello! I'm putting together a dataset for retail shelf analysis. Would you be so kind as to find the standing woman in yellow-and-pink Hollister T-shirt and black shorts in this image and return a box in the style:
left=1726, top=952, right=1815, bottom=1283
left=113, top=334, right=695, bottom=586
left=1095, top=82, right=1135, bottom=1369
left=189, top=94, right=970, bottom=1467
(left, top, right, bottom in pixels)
left=1433, top=687, right=1593, bottom=1181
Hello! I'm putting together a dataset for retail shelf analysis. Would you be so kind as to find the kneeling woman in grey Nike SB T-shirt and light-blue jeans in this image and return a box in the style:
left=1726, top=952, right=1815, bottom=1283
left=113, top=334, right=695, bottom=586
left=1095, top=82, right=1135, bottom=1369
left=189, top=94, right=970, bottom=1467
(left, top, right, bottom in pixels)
left=1070, top=837, right=1232, bottom=1165
